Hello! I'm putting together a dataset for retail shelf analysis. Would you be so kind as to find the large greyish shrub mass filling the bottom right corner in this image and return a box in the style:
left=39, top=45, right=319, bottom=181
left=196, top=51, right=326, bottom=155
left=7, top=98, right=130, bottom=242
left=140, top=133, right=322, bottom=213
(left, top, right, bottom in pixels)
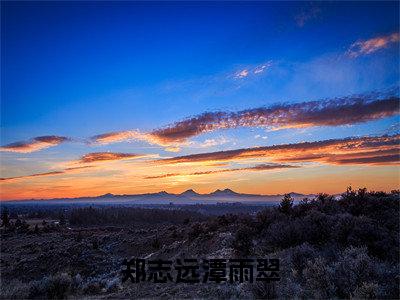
left=298, top=247, right=399, bottom=299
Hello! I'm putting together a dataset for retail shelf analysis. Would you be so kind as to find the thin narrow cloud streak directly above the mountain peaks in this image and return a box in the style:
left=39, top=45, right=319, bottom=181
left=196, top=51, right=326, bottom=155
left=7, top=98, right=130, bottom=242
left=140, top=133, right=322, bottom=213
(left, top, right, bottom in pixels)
left=144, top=164, right=298, bottom=179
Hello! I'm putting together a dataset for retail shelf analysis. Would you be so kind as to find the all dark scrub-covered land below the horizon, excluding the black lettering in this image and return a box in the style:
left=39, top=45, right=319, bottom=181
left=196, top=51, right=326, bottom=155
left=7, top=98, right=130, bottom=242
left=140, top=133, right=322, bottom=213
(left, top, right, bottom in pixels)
left=0, top=188, right=400, bottom=299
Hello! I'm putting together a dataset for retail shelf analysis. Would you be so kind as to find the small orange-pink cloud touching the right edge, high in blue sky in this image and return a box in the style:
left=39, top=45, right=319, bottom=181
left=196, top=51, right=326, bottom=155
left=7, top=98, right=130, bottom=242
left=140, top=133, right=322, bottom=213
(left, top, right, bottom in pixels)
left=347, top=32, right=400, bottom=58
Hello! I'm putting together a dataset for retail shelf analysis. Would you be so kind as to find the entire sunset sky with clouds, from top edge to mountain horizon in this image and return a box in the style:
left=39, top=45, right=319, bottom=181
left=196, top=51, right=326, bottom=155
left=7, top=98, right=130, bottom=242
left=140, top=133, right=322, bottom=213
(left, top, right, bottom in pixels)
left=0, top=1, right=400, bottom=200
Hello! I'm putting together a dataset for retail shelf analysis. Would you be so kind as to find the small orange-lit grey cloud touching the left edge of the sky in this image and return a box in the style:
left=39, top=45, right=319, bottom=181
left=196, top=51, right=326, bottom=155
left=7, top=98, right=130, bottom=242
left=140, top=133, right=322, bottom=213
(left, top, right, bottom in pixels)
left=0, top=135, right=70, bottom=153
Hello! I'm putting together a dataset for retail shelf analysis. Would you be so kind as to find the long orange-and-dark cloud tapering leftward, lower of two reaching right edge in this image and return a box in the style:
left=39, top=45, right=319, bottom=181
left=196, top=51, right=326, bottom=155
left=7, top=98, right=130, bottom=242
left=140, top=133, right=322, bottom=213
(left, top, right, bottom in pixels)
left=159, top=135, right=400, bottom=164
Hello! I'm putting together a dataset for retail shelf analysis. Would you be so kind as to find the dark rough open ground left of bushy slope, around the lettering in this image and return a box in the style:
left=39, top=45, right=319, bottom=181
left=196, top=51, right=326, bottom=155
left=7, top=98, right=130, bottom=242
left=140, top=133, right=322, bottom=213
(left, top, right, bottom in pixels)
left=0, top=218, right=250, bottom=298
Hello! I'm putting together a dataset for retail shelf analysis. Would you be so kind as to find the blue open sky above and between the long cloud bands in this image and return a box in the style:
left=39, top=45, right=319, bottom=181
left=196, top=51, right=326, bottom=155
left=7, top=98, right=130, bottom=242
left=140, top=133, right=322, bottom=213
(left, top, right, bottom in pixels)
left=1, top=1, right=399, bottom=199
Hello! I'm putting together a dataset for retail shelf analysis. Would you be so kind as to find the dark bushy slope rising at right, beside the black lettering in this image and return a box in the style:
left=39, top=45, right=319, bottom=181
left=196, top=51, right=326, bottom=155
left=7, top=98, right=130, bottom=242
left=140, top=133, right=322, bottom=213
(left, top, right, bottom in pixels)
left=233, top=188, right=399, bottom=299
